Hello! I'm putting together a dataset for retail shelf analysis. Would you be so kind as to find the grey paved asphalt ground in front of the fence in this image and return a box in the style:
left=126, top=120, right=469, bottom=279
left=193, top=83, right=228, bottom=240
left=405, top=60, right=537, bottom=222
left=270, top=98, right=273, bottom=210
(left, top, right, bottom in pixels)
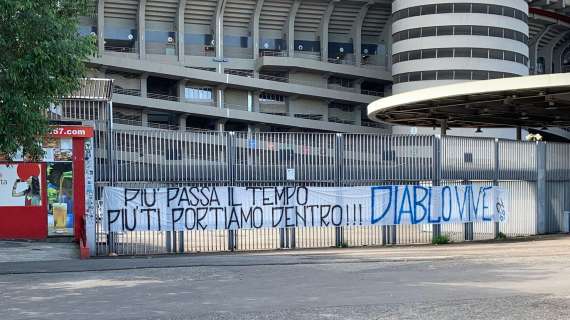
left=0, top=237, right=570, bottom=319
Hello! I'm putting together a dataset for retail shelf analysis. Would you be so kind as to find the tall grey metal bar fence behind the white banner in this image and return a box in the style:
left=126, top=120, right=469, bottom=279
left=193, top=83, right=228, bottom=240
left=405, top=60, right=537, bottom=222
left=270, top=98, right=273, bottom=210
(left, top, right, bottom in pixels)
left=89, top=124, right=570, bottom=255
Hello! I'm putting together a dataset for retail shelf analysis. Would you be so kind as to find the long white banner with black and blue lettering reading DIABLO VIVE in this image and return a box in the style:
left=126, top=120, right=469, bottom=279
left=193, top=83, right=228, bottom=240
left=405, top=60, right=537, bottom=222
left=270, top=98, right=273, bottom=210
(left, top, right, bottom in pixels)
left=103, top=185, right=509, bottom=232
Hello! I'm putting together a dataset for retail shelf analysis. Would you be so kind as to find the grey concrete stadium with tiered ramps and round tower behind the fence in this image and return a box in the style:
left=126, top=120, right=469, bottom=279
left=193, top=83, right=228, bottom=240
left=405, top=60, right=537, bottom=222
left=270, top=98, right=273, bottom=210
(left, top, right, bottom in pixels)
left=80, top=0, right=570, bottom=139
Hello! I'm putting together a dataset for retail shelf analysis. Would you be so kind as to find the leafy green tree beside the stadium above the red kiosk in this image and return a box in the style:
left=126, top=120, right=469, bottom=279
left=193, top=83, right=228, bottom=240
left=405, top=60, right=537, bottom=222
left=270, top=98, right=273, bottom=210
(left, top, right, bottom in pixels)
left=0, top=0, right=96, bottom=159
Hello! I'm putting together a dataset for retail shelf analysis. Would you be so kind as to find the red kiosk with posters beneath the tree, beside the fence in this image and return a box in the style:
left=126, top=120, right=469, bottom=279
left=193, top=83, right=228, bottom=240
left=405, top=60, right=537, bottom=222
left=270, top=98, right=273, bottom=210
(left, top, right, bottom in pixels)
left=0, top=125, right=93, bottom=251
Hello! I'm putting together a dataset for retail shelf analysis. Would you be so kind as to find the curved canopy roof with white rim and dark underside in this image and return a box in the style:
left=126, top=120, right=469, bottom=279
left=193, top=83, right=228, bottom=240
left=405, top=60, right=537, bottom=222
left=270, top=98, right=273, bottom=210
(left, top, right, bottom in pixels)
left=368, top=73, right=570, bottom=127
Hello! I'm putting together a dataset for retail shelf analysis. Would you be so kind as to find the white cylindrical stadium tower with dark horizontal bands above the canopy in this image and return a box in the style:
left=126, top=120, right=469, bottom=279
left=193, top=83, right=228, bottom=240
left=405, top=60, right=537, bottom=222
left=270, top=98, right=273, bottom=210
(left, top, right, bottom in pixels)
left=392, top=0, right=529, bottom=94
